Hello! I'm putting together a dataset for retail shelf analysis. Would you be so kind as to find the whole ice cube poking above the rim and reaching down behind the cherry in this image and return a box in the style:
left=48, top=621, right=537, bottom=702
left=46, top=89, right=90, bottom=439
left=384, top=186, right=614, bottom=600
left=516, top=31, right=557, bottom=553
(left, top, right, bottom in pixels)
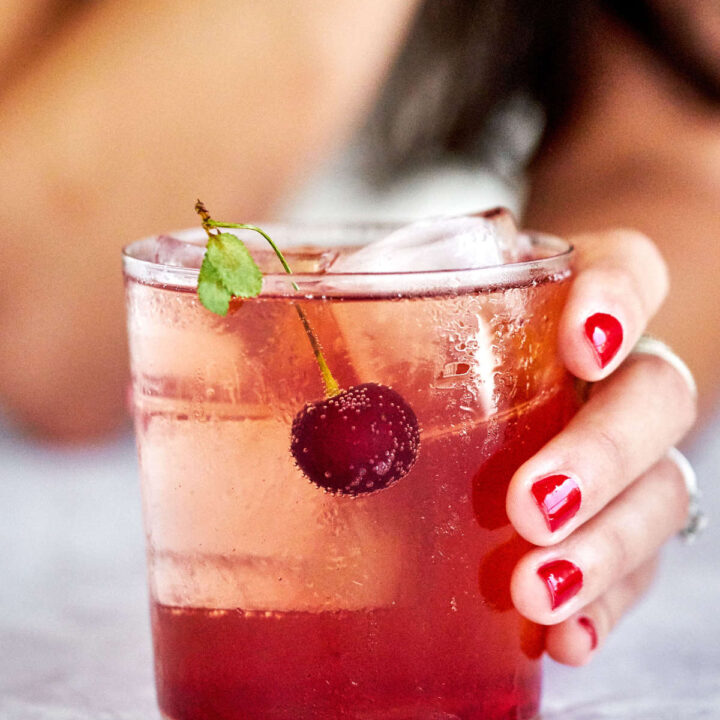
left=330, top=214, right=529, bottom=431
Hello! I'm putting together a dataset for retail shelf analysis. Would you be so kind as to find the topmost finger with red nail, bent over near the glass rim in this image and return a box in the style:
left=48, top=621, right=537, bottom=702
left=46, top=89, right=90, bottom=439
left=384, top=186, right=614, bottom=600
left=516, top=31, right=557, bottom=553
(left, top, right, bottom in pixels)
left=559, top=230, right=668, bottom=382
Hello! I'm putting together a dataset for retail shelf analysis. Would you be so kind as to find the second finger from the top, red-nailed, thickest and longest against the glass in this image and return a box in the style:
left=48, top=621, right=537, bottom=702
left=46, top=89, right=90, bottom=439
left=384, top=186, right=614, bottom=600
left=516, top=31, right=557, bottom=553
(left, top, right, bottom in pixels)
left=506, top=355, right=696, bottom=546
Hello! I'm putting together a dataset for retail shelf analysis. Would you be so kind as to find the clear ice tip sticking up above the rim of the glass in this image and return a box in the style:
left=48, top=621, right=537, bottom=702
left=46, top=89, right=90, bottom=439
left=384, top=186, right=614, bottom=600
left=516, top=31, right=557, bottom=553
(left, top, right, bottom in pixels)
left=329, top=208, right=520, bottom=273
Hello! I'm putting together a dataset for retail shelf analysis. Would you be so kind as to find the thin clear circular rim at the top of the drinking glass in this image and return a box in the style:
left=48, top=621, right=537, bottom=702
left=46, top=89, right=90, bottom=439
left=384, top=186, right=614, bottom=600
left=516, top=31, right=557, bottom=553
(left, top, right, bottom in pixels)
left=122, top=222, right=575, bottom=297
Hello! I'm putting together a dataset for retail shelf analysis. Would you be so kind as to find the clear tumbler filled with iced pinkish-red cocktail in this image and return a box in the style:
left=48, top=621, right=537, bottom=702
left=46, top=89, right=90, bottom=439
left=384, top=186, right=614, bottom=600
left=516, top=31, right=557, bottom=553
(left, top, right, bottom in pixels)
left=124, top=219, right=576, bottom=720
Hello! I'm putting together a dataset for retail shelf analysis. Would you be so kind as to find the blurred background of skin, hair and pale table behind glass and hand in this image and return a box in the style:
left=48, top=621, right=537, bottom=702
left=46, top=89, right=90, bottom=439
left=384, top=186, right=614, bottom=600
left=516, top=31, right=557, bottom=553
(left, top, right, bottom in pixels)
left=0, top=0, right=720, bottom=720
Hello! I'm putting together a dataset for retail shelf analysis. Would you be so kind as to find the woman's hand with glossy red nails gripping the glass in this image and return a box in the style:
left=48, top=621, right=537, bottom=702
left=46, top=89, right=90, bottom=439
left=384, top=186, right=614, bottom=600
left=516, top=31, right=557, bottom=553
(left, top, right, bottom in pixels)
left=507, top=230, right=696, bottom=665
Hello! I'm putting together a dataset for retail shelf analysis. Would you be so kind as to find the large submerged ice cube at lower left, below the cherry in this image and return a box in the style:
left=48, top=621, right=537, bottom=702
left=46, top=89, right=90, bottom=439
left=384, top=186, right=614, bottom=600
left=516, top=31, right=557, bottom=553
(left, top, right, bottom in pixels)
left=143, top=414, right=412, bottom=612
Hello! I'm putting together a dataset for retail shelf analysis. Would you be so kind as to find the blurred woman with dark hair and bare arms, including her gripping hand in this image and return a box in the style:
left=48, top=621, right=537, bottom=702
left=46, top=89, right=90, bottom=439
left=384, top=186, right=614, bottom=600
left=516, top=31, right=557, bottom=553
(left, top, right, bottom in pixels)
left=0, top=0, right=720, bottom=664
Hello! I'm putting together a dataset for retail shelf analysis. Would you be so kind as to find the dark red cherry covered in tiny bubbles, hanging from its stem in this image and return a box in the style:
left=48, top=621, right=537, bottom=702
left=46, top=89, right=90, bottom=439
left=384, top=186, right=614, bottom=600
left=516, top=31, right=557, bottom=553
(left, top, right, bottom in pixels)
left=290, top=383, right=420, bottom=495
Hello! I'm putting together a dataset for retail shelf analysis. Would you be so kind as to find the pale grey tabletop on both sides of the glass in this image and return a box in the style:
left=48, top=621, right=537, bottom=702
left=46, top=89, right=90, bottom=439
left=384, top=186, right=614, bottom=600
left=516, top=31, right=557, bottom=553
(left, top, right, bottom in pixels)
left=0, top=414, right=720, bottom=720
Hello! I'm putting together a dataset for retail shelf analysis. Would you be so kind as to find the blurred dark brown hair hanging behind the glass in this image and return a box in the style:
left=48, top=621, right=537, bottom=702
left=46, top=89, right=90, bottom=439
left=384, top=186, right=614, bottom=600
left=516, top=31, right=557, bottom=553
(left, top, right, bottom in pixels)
left=368, top=0, right=707, bottom=182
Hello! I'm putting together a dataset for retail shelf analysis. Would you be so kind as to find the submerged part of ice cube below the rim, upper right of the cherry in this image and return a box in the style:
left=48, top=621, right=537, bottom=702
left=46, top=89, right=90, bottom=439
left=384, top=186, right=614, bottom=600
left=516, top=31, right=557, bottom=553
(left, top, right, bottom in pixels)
left=332, top=294, right=500, bottom=430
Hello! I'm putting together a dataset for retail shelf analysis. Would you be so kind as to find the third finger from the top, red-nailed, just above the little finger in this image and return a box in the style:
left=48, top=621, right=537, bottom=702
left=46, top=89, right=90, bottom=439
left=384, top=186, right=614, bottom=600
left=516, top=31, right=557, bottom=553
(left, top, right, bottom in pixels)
left=510, top=458, right=689, bottom=625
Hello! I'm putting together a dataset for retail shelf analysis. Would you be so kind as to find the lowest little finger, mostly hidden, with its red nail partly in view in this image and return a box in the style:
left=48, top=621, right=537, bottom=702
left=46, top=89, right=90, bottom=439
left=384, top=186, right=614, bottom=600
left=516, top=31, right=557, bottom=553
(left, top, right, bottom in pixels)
left=545, top=557, right=658, bottom=666
